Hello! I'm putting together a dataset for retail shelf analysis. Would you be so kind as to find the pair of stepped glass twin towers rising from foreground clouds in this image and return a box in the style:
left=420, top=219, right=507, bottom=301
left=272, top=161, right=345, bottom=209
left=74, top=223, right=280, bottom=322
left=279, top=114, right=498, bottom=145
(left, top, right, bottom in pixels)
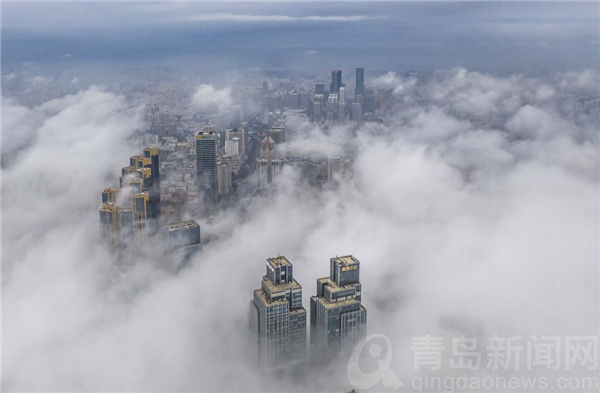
left=250, top=255, right=367, bottom=368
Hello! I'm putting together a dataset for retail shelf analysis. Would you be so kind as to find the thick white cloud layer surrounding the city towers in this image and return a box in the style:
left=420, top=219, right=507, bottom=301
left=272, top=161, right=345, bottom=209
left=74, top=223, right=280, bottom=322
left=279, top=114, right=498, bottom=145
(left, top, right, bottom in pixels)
left=3, top=69, right=599, bottom=391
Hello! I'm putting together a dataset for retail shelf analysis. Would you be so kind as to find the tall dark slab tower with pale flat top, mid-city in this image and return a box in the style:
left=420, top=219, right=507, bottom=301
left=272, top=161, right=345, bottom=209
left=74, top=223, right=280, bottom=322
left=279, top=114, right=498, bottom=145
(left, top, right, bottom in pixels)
left=196, top=131, right=218, bottom=211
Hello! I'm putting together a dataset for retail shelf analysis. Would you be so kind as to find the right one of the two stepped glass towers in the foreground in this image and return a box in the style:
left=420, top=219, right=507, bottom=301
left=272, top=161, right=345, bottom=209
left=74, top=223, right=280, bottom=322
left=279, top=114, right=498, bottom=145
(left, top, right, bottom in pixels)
left=310, top=255, right=367, bottom=355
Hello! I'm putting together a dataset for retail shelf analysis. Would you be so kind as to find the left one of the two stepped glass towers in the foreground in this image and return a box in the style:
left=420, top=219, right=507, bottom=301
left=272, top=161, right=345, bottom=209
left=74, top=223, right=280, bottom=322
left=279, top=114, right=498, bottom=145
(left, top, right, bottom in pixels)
left=250, top=256, right=306, bottom=369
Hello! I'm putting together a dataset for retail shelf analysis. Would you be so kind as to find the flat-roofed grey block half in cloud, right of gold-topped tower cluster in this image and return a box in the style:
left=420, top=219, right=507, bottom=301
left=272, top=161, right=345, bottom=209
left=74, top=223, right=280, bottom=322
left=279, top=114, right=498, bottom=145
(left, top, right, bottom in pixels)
left=165, top=220, right=202, bottom=268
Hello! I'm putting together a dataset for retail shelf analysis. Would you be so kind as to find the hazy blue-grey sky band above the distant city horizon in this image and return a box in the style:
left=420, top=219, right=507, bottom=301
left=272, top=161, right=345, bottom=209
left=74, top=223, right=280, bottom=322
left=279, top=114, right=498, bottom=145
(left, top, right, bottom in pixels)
left=2, top=1, right=600, bottom=77
